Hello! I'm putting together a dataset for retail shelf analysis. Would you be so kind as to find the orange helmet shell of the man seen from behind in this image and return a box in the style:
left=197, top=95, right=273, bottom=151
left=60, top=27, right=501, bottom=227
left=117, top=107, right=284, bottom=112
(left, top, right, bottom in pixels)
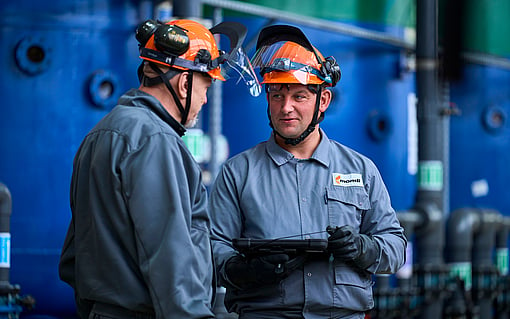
left=141, top=19, right=225, bottom=81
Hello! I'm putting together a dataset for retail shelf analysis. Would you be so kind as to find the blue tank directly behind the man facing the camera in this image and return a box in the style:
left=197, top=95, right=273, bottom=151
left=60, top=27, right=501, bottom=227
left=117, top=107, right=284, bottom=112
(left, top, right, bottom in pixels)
left=223, top=18, right=417, bottom=209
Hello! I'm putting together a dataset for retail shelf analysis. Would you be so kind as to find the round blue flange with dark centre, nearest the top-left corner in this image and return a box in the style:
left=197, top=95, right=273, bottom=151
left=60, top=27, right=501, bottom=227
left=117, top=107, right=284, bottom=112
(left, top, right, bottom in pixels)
left=15, top=36, right=53, bottom=75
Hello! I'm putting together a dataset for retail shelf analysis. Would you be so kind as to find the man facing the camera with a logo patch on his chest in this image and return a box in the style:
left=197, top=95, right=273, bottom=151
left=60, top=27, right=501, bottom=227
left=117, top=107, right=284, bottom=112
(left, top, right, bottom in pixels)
left=210, top=25, right=407, bottom=319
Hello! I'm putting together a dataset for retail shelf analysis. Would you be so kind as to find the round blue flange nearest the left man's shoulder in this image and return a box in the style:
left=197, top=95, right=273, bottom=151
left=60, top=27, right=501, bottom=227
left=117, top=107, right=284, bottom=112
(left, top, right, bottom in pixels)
left=88, top=70, right=119, bottom=110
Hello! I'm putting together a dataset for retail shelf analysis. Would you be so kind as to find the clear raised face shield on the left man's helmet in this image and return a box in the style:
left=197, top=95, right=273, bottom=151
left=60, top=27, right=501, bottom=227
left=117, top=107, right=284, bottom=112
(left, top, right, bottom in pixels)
left=210, top=22, right=262, bottom=96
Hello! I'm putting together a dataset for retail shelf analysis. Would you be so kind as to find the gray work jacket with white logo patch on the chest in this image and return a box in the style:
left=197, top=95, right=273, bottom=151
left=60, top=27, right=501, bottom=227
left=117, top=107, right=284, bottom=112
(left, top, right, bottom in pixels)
left=210, top=130, right=407, bottom=318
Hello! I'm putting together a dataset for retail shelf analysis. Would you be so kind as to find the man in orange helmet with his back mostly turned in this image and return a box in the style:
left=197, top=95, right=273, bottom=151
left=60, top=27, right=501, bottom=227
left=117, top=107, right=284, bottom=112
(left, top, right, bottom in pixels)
left=59, top=20, right=260, bottom=319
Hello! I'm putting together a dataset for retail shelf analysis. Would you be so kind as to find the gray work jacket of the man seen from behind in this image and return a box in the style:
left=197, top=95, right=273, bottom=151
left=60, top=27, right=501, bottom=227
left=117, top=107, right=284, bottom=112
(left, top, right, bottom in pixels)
left=59, top=89, right=214, bottom=318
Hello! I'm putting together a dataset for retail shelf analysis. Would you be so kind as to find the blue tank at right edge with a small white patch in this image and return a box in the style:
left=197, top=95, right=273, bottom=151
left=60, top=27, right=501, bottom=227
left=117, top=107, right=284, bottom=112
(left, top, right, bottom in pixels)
left=450, top=64, right=510, bottom=215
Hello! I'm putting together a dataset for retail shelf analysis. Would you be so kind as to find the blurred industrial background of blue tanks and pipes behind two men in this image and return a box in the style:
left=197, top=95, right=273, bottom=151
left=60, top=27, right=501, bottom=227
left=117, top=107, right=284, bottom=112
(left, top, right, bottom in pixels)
left=0, top=0, right=510, bottom=319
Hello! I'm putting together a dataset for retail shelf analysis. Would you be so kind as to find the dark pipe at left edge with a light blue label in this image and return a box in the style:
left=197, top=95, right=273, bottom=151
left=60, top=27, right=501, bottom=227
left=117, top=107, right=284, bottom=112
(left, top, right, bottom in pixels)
left=0, top=183, right=12, bottom=293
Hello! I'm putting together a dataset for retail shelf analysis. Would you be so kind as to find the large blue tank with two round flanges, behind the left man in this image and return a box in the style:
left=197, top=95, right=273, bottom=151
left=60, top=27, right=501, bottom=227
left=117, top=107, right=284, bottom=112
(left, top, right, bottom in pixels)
left=0, top=0, right=146, bottom=316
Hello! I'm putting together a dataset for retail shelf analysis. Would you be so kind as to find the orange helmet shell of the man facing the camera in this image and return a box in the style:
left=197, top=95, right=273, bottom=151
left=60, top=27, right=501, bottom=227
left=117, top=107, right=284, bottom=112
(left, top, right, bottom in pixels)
left=262, top=41, right=325, bottom=85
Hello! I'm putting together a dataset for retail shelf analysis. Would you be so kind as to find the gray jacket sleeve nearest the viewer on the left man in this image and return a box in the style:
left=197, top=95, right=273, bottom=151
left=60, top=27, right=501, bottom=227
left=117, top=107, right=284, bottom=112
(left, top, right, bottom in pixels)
left=120, top=134, right=214, bottom=318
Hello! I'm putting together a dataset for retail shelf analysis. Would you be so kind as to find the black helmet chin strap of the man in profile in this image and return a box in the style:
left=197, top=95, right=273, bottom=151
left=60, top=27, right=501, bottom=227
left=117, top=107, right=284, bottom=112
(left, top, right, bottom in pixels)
left=140, top=62, right=193, bottom=126
